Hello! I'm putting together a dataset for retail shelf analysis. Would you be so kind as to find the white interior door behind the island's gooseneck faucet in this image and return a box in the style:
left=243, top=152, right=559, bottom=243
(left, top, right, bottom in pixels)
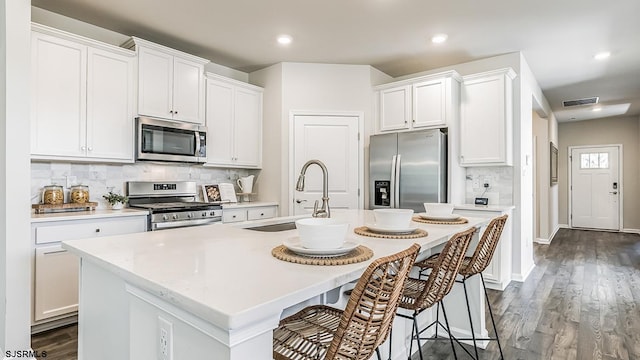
left=291, top=115, right=362, bottom=215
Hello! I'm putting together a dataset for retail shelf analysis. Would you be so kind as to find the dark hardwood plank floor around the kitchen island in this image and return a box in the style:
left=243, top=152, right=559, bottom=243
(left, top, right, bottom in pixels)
left=32, top=229, right=640, bottom=360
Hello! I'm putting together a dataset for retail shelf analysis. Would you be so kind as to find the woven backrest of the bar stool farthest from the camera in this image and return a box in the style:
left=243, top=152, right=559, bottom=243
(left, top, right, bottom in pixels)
left=460, top=214, right=509, bottom=276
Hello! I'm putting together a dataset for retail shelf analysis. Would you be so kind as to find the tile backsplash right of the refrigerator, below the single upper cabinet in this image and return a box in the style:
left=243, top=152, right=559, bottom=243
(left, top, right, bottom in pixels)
left=465, top=166, right=513, bottom=205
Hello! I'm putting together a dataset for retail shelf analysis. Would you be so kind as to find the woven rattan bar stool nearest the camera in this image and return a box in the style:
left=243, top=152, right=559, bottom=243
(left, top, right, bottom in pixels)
left=273, top=244, right=420, bottom=360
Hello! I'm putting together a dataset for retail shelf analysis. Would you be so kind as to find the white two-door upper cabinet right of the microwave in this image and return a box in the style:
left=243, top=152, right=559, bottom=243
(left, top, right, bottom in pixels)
left=205, top=74, right=263, bottom=168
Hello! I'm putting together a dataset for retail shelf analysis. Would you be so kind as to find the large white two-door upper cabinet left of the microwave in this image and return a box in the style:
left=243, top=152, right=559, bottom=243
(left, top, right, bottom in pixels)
left=31, top=24, right=135, bottom=162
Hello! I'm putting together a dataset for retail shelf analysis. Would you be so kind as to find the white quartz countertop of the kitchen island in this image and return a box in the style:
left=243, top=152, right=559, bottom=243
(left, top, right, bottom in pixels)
left=63, top=210, right=487, bottom=329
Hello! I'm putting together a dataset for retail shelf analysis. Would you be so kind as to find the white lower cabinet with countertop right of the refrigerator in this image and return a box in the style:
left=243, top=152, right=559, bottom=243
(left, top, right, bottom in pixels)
left=453, top=205, right=513, bottom=291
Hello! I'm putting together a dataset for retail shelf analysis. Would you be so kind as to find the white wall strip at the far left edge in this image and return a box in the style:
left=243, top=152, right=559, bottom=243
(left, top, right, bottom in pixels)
left=0, top=0, right=31, bottom=356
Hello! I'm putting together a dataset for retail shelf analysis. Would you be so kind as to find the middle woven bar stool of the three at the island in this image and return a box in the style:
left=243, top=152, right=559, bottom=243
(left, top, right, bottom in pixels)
left=398, top=228, right=476, bottom=360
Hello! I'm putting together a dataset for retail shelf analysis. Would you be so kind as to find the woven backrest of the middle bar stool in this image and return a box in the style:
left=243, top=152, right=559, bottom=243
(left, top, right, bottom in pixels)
left=414, top=227, right=476, bottom=309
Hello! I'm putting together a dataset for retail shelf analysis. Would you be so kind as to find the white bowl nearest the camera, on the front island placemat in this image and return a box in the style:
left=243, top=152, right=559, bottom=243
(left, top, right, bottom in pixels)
left=296, top=218, right=349, bottom=249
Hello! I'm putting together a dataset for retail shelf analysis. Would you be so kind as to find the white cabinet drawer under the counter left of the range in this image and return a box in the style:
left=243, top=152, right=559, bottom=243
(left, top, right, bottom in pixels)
left=34, top=217, right=147, bottom=244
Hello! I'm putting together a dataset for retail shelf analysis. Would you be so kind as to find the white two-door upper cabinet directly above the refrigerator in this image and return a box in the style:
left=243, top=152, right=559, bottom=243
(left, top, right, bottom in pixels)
left=375, top=71, right=461, bottom=132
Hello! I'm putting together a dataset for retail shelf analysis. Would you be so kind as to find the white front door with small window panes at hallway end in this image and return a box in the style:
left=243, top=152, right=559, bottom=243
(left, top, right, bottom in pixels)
left=571, top=146, right=620, bottom=230
